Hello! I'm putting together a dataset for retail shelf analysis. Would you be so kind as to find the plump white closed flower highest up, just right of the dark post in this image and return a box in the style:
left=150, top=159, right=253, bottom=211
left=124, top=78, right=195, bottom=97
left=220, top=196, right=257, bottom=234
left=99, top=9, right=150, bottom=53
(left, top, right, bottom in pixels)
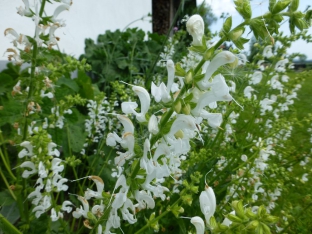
left=186, top=15, right=205, bottom=46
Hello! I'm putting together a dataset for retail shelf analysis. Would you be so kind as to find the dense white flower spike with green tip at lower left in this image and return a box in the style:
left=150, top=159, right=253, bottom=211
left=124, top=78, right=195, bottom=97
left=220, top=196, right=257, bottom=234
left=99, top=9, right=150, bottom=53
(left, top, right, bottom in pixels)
left=18, top=130, right=70, bottom=221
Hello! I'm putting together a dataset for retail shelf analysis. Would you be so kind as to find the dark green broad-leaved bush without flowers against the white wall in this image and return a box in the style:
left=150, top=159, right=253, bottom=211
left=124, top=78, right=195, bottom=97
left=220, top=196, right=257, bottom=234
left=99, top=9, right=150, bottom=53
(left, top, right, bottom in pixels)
left=81, top=28, right=165, bottom=93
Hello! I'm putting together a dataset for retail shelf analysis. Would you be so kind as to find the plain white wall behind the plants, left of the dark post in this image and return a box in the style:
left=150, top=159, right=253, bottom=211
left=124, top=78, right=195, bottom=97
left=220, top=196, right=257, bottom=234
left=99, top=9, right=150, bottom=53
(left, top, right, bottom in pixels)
left=0, top=0, right=152, bottom=60
